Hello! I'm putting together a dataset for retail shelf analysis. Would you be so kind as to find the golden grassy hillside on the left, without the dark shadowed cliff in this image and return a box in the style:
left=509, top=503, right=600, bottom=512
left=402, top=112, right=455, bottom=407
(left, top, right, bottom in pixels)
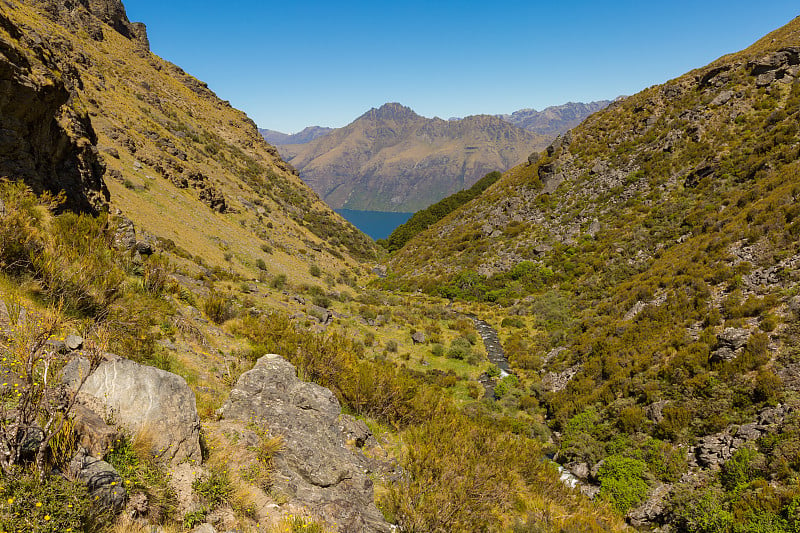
left=2, top=0, right=375, bottom=288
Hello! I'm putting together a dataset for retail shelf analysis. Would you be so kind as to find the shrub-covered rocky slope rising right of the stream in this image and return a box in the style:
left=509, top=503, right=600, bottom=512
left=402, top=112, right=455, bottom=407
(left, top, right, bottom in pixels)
left=386, top=15, right=800, bottom=531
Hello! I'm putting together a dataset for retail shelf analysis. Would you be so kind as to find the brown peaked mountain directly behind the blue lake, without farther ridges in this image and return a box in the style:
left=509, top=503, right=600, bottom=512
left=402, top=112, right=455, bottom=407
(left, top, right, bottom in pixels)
left=281, top=104, right=546, bottom=212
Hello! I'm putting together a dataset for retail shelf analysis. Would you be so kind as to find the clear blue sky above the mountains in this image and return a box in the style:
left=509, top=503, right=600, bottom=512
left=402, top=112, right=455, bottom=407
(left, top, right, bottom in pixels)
left=123, top=0, right=800, bottom=133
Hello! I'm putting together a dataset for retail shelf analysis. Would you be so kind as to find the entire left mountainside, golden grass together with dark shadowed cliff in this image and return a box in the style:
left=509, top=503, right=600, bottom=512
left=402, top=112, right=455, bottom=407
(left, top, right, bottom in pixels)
left=0, top=0, right=374, bottom=280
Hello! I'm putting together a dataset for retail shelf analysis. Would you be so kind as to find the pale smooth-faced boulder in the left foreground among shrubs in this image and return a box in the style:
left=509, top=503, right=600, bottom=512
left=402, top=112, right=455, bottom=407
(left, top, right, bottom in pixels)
left=65, top=356, right=202, bottom=464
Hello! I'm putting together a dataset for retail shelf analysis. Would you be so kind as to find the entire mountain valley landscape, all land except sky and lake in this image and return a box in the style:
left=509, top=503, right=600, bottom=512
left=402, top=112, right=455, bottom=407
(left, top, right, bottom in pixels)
left=0, top=0, right=800, bottom=533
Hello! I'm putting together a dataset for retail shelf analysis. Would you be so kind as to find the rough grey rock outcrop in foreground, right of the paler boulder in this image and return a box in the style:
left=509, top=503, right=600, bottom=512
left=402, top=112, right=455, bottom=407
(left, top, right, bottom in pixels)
left=222, top=355, right=390, bottom=533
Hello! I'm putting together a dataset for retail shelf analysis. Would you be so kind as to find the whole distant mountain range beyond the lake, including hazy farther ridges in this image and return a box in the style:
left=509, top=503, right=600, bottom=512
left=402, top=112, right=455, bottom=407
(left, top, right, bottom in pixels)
left=268, top=101, right=610, bottom=211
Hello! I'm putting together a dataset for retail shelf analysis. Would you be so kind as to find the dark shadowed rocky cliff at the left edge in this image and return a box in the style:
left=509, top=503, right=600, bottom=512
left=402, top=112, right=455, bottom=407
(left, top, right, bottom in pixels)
left=0, top=11, right=108, bottom=212
